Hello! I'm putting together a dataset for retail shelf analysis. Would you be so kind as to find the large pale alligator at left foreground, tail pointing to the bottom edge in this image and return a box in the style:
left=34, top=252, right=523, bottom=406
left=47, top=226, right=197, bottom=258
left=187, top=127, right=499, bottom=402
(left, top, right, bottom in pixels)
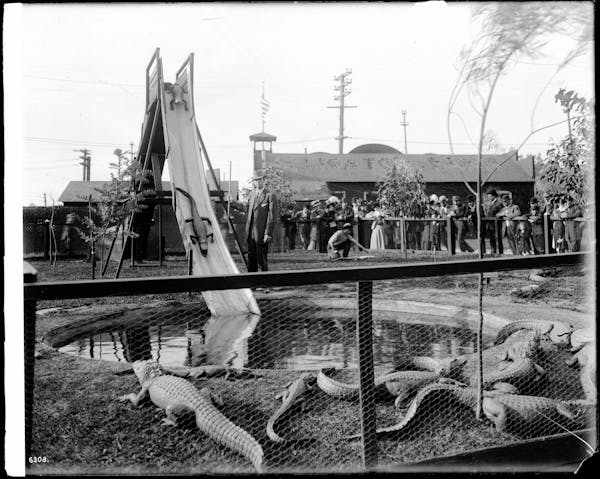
left=118, top=360, right=263, bottom=471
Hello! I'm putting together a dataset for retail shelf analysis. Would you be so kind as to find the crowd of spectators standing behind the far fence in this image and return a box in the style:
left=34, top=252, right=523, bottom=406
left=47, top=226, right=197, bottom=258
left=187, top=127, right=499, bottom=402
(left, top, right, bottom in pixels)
left=281, top=189, right=585, bottom=255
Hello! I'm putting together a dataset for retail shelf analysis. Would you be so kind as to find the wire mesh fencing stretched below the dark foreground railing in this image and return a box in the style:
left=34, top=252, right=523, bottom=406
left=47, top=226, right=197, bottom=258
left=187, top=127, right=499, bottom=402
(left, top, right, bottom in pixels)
left=25, top=255, right=596, bottom=474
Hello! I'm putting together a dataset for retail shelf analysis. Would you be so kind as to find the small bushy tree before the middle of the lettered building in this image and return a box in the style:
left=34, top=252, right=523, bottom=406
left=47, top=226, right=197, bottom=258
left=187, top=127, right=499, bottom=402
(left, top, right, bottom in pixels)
left=377, top=159, right=427, bottom=218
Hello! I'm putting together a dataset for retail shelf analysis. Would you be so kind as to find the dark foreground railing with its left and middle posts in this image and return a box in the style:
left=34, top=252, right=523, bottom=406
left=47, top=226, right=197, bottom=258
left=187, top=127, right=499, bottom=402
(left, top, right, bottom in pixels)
left=24, top=253, right=592, bottom=468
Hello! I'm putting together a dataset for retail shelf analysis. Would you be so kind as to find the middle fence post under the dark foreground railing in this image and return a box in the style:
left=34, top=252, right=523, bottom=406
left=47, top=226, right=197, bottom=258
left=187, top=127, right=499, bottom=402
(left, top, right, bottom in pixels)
left=356, top=281, right=377, bottom=469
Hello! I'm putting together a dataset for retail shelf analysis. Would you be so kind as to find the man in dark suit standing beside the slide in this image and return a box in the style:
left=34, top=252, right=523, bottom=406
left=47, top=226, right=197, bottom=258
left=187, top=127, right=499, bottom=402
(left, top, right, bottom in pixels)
left=246, top=174, right=277, bottom=273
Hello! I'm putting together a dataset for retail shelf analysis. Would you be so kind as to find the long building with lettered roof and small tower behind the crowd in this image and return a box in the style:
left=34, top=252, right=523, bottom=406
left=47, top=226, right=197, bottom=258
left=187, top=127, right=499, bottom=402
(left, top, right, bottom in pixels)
left=250, top=134, right=535, bottom=208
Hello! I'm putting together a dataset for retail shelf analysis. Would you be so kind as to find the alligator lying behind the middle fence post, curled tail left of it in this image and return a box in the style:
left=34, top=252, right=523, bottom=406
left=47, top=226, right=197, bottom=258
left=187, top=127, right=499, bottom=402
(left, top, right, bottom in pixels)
left=317, top=358, right=466, bottom=399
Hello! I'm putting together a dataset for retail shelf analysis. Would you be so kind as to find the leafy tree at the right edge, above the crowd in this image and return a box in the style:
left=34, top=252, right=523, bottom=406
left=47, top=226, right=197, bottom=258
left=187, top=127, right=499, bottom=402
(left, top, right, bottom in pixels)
left=540, top=88, right=595, bottom=208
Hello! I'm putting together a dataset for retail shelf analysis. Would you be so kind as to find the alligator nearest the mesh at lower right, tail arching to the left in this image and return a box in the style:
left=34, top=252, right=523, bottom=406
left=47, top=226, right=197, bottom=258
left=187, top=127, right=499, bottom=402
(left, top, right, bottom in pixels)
left=347, top=379, right=582, bottom=439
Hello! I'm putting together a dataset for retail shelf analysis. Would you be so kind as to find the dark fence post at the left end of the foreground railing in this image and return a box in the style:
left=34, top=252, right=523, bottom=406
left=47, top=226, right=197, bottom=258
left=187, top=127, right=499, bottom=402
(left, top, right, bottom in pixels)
left=23, top=261, right=37, bottom=464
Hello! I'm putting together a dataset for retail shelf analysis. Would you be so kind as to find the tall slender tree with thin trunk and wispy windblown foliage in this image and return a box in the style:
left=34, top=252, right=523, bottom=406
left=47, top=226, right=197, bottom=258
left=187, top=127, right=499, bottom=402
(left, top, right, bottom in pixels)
left=447, top=2, right=594, bottom=424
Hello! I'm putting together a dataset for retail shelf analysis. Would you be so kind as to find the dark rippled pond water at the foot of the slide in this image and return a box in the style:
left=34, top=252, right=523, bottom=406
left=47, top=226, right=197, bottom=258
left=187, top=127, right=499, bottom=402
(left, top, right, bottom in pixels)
left=60, top=311, right=486, bottom=370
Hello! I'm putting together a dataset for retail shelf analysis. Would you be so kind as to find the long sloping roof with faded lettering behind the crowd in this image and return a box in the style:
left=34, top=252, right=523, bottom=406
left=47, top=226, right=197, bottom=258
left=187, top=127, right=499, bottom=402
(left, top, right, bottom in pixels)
left=265, top=152, right=534, bottom=183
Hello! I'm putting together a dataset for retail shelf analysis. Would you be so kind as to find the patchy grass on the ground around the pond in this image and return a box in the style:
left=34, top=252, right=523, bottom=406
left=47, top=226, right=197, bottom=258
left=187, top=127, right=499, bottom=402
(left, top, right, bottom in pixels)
left=28, top=251, right=584, bottom=474
